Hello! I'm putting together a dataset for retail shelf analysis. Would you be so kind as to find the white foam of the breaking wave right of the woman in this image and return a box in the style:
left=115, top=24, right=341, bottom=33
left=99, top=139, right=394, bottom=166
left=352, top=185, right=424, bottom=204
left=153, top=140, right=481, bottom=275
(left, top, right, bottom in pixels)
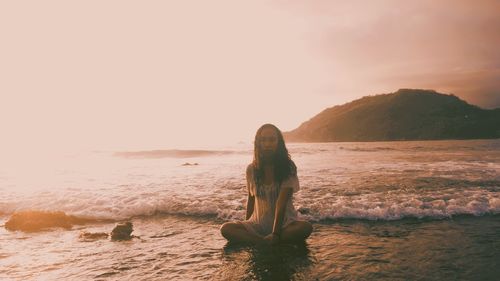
left=294, top=190, right=500, bottom=221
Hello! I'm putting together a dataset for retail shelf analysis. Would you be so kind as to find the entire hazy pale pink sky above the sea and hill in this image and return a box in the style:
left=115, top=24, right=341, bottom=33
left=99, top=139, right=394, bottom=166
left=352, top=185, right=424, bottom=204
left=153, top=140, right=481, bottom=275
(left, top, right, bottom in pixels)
left=0, top=0, right=500, bottom=151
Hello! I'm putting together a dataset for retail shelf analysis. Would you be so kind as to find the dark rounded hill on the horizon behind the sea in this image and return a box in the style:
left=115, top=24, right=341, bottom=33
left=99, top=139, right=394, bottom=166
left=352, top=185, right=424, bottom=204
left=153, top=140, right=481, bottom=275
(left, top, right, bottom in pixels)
left=284, top=89, right=500, bottom=142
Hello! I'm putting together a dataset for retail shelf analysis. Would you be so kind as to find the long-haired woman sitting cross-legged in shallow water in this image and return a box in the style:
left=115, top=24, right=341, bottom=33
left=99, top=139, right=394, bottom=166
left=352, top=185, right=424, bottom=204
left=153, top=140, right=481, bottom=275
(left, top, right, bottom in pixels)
left=220, top=124, right=312, bottom=244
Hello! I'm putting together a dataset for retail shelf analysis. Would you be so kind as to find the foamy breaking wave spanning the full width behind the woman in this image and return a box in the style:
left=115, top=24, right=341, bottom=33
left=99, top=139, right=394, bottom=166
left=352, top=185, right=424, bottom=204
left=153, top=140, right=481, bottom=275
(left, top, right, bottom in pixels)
left=0, top=188, right=500, bottom=221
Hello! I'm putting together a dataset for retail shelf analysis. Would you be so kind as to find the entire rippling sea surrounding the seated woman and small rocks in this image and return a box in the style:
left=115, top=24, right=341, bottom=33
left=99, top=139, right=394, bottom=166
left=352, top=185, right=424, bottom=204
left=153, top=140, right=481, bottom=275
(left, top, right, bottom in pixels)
left=0, top=140, right=500, bottom=280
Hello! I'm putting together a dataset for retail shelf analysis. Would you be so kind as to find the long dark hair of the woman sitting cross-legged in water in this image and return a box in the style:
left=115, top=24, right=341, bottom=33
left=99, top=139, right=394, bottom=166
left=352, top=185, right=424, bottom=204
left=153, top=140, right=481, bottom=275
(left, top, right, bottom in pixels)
left=252, top=123, right=297, bottom=195
